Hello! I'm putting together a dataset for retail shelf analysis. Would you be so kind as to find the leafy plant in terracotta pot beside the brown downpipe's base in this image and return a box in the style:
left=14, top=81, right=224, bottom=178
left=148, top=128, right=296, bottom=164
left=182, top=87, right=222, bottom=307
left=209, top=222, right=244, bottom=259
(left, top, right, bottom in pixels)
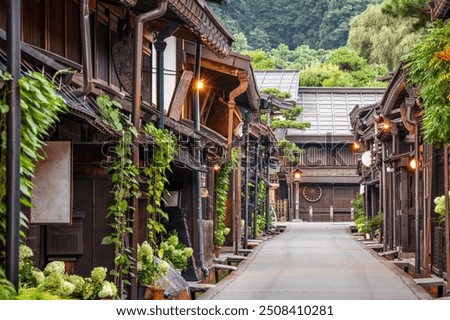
left=137, top=241, right=169, bottom=300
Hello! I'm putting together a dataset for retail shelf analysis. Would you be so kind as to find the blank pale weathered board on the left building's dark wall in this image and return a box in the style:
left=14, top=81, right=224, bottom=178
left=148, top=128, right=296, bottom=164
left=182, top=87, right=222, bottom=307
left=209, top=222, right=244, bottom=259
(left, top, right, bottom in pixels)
left=30, top=141, right=72, bottom=224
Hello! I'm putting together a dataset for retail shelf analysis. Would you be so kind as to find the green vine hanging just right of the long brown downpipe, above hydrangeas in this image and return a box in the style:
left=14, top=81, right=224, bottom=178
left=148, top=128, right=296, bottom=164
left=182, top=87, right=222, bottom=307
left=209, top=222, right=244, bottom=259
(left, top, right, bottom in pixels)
left=142, top=123, right=178, bottom=252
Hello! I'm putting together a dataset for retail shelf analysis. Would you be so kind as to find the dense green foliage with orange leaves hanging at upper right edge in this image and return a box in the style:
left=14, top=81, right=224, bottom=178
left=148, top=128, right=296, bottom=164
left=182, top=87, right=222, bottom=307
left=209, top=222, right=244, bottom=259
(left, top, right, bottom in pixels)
left=406, top=21, right=450, bottom=146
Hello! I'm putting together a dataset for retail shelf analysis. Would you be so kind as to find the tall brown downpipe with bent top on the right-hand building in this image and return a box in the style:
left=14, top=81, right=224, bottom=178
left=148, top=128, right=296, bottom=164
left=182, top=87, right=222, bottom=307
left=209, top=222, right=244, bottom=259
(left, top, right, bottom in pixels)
left=406, top=98, right=420, bottom=275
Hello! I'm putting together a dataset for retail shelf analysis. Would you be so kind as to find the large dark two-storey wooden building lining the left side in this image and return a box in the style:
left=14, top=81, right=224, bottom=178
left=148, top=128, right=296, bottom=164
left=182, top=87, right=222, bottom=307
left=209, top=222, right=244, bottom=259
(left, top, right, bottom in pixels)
left=0, top=0, right=266, bottom=298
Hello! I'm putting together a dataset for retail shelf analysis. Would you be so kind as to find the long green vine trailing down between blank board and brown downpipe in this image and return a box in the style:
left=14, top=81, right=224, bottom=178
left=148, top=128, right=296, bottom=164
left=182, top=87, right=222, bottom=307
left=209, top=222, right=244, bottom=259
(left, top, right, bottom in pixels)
left=97, top=95, right=139, bottom=288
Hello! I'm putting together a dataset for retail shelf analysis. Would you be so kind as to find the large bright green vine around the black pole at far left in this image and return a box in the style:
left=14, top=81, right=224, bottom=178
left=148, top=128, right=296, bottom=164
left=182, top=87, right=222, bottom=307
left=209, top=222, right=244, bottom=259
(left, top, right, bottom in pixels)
left=0, top=71, right=68, bottom=260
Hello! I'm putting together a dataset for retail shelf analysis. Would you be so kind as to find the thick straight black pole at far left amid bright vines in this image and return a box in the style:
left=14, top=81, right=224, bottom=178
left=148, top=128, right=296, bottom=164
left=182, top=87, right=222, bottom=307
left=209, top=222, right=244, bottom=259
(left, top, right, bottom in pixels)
left=5, top=0, right=21, bottom=291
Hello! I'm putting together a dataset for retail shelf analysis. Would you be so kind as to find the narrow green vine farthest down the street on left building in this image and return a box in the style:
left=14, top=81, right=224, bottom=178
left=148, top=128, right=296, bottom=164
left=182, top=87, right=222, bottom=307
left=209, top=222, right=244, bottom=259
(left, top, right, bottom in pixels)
left=214, top=148, right=239, bottom=246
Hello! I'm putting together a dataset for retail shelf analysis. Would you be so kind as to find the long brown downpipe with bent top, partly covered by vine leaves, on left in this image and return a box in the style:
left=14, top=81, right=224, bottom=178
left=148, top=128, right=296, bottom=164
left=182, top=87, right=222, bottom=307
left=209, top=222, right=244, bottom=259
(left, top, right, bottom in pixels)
left=131, top=0, right=168, bottom=300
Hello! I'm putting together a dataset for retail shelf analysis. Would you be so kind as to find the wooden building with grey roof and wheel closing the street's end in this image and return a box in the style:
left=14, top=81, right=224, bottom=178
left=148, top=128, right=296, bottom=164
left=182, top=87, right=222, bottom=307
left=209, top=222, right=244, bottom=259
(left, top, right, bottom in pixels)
left=281, top=87, right=384, bottom=221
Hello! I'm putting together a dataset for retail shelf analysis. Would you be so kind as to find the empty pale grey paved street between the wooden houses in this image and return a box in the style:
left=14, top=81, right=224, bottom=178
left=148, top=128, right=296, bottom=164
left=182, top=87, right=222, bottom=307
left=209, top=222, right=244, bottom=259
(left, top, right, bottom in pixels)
left=200, top=223, right=431, bottom=300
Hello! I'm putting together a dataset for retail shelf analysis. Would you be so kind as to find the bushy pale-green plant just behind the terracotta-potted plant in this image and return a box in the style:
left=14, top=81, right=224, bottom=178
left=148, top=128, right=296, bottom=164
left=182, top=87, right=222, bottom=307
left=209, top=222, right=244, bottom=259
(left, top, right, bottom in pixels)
left=159, top=232, right=193, bottom=271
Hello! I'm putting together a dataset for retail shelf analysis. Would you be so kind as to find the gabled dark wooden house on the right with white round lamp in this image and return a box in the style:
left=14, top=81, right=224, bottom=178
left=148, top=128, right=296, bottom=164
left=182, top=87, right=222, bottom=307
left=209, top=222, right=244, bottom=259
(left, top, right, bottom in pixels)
left=350, top=66, right=431, bottom=256
